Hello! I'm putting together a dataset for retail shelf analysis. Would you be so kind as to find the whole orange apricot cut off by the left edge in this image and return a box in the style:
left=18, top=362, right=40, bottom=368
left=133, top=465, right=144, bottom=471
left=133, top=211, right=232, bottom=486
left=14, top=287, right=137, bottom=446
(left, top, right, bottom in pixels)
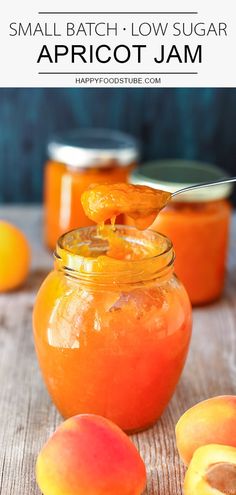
left=0, top=220, right=30, bottom=292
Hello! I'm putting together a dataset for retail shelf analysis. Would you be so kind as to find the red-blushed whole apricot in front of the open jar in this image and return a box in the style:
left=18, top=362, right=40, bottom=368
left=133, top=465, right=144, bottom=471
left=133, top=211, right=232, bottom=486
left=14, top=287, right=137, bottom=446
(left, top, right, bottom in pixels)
left=36, top=414, right=146, bottom=495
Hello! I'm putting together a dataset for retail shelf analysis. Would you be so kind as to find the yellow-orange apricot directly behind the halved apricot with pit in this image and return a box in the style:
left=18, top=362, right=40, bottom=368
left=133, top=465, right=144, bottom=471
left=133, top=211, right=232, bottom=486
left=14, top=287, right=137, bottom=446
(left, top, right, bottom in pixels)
left=175, top=395, right=236, bottom=464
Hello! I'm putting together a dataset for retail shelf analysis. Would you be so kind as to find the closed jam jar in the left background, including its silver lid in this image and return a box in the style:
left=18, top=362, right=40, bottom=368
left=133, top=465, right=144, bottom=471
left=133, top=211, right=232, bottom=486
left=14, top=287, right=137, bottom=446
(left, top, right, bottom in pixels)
left=44, top=129, right=139, bottom=249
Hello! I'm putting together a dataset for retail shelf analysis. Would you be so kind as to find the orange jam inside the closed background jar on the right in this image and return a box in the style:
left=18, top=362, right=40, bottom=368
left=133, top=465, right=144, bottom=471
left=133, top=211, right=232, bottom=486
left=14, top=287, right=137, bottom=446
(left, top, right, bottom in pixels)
left=151, top=200, right=231, bottom=305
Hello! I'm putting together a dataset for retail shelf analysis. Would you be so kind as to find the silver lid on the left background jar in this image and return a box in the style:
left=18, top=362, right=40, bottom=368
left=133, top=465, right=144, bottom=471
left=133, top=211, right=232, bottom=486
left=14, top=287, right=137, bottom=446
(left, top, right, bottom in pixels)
left=48, top=129, right=139, bottom=168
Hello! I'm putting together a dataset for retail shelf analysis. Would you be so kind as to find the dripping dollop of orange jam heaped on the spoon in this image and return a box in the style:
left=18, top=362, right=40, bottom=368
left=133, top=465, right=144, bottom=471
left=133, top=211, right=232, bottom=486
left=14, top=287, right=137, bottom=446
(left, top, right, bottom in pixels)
left=81, top=183, right=172, bottom=230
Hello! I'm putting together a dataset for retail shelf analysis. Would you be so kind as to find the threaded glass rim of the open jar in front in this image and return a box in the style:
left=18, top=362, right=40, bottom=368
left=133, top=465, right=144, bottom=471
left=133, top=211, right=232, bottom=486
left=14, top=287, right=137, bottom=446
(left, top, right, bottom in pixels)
left=54, top=225, right=175, bottom=283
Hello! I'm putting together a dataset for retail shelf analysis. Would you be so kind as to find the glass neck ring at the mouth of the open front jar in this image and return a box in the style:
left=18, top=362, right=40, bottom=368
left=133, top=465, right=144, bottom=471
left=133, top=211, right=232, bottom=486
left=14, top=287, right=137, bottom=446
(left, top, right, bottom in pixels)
left=54, top=225, right=175, bottom=287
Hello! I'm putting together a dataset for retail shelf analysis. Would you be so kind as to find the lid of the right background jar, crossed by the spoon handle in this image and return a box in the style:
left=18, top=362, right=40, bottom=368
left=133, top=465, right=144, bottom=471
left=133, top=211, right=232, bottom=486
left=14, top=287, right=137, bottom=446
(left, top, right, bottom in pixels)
left=130, top=160, right=233, bottom=203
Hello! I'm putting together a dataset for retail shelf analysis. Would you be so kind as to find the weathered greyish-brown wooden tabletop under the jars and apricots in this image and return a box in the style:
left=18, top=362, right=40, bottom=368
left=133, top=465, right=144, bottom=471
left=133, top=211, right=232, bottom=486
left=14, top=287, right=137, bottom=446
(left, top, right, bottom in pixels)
left=0, top=206, right=236, bottom=495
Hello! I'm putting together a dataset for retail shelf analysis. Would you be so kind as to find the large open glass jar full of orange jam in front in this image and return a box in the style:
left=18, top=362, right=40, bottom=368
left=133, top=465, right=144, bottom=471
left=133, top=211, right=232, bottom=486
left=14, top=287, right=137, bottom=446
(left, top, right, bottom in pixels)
left=33, top=226, right=191, bottom=432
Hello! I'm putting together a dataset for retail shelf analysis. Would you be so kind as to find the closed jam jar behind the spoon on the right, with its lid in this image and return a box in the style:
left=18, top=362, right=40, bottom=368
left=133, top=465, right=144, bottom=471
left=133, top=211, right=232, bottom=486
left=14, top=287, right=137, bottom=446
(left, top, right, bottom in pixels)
left=131, top=160, right=232, bottom=305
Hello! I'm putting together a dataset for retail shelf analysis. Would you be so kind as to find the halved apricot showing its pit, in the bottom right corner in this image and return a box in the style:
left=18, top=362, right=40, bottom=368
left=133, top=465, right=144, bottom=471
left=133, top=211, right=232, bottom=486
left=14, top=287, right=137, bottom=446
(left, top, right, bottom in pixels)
left=184, top=446, right=236, bottom=495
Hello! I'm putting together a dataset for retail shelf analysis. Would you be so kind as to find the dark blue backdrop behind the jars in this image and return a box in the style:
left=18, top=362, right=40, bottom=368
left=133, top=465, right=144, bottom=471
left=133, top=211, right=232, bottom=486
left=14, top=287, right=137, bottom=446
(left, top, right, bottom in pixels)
left=0, top=88, right=236, bottom=202
